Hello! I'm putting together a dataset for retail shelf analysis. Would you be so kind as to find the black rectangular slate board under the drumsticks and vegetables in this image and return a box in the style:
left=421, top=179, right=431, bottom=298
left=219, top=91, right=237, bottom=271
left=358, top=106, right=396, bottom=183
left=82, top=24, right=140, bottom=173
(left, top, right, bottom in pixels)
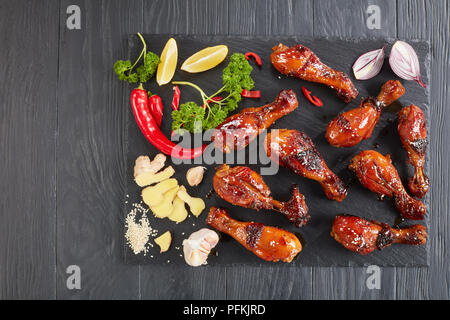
left=124, top=35, right=432, bottom=267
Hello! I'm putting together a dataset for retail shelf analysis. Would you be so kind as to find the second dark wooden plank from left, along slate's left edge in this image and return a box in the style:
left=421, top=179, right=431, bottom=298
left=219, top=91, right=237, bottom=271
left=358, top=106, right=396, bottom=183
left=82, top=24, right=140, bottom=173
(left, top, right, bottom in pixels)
left=57, top=0, right=142, bottom=299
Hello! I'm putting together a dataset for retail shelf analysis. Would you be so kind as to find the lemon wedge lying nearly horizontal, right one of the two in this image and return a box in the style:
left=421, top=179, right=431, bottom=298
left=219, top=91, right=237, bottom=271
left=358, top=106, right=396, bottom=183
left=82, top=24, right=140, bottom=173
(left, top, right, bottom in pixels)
left=181, top=45, right=228, bottom=73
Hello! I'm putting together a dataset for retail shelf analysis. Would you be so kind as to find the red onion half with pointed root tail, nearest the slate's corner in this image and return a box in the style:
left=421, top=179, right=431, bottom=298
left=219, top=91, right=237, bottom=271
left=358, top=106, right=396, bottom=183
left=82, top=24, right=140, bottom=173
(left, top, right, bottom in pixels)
left=389, top=41, right=427, bottom=88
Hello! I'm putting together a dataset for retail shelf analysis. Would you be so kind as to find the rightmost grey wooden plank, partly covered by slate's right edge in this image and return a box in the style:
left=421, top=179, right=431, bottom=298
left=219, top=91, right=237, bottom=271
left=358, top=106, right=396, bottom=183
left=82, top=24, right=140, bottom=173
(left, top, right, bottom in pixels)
left=396, top=0, right=450, bottom=300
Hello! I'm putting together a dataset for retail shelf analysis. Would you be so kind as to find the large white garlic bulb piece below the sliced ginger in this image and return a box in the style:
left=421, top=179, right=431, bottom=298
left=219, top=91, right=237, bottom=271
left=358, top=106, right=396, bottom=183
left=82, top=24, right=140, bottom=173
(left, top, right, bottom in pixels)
left=183, top=228, right=219, bottom=267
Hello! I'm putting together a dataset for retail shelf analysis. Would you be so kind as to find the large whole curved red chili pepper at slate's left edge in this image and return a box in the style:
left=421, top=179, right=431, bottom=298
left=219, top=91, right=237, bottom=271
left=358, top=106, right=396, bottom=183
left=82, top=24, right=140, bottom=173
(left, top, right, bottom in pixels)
left=130, top=88, right=207, bottom=159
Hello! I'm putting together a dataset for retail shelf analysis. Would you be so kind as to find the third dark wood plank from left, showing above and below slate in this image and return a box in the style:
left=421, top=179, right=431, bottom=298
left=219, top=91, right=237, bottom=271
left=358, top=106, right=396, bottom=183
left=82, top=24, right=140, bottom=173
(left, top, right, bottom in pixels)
left=141, top=0, right=228, bottom=299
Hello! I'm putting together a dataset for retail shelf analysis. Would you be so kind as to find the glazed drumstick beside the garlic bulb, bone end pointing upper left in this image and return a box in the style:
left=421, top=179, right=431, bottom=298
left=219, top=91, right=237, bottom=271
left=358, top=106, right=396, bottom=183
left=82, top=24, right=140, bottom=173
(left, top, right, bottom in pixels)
left=206, top=207, right=302, bottom=262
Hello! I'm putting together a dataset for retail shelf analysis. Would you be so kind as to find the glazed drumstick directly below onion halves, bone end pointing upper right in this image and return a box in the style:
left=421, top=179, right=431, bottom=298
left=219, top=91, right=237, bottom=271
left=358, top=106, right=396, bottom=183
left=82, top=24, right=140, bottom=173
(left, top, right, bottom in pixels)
left=325, top=80, right=405, bottom=147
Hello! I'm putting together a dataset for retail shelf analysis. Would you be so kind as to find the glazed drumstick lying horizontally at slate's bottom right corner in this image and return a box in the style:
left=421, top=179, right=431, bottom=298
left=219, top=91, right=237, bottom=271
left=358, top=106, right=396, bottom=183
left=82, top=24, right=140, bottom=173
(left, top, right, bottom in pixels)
left=331, top=215, right=427, bottom=255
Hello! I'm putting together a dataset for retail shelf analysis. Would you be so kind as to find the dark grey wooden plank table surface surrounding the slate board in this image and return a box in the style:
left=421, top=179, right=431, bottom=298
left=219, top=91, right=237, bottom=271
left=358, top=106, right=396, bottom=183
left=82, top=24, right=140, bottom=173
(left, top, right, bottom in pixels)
left=0, top=0, right=450, bottom=299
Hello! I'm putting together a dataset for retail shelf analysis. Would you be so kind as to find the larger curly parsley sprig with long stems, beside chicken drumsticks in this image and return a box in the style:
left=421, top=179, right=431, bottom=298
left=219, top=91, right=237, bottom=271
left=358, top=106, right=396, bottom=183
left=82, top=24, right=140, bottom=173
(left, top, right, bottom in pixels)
left=172, top=53, right=255, bottom=133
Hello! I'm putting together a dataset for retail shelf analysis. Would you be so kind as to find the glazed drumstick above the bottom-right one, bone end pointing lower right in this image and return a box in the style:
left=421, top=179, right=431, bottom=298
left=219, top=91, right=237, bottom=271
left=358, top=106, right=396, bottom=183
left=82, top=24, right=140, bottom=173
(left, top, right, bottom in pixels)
left=349, top=150, right=426, bottom=220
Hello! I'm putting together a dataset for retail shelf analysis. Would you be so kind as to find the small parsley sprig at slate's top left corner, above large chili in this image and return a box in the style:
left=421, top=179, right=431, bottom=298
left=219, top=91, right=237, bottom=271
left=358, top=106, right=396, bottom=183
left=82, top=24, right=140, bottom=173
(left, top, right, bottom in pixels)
left=114, top=33, right=159, bottom=83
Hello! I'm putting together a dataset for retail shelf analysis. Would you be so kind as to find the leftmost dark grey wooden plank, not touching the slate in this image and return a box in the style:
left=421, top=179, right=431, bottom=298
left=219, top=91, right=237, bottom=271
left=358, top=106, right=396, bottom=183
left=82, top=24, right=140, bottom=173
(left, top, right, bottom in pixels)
left=0, top=1, right=59, bottom=299
